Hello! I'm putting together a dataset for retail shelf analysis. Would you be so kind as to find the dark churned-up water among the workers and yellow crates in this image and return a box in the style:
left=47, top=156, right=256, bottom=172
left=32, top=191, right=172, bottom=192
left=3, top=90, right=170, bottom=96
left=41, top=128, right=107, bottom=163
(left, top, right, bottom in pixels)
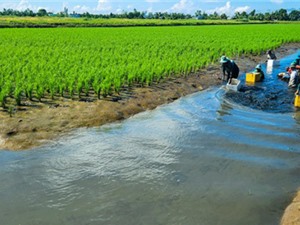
left=225, top=52, right=300, bottom=113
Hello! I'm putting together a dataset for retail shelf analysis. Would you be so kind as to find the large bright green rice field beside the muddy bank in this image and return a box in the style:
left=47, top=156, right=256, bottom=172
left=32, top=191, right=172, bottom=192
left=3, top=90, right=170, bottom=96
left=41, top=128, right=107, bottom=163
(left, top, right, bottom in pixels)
left=0, top=24, right=300, bottom=107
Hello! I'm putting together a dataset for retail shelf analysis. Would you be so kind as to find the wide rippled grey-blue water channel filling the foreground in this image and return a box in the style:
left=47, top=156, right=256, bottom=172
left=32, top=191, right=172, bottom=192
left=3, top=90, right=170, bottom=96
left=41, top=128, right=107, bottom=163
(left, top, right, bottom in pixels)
left=0, top=55, right=300, bottom=225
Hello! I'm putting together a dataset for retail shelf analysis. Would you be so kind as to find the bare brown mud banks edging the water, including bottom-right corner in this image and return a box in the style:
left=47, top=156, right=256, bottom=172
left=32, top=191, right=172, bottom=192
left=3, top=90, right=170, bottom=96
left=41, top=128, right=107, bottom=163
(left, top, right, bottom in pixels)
left=0, top=43, right=300, bottom=225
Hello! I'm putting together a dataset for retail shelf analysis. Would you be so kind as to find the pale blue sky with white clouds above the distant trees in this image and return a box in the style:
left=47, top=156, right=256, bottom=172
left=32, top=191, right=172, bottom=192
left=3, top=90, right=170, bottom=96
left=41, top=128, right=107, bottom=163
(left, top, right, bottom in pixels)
left=0, top=0, right=300, bottom=16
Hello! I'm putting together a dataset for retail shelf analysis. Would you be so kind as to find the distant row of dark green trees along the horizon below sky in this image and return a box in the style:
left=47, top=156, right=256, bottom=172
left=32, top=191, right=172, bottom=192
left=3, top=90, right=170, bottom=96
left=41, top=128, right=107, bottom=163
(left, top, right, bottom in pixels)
left=0, top=8, right=300, bottom=21
